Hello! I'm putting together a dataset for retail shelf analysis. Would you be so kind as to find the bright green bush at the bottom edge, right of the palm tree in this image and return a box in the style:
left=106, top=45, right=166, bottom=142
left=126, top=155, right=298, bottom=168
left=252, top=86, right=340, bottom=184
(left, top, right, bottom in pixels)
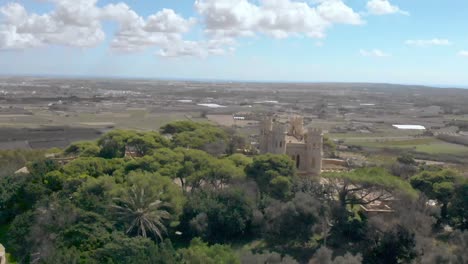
left=179, top=238, right=240, bottom=264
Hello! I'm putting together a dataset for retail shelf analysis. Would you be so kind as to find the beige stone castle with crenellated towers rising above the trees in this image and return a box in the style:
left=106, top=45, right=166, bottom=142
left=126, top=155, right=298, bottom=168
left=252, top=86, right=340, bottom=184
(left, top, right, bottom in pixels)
left=259, top=116, right=323, bottom=175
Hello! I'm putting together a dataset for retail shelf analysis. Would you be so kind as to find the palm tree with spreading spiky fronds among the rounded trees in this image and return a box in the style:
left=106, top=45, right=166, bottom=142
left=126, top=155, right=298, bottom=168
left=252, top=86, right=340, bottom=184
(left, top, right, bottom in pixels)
left=112, top=187, right=171, bottom=240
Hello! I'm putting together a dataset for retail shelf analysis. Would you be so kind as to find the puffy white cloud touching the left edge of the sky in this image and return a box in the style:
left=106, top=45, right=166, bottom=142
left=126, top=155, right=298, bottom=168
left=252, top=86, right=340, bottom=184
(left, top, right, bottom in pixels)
left=0, top=0, right=105, bottom=49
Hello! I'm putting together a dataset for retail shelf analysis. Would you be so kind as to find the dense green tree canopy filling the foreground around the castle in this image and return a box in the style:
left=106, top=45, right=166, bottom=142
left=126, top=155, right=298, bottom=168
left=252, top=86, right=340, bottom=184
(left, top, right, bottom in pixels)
left=0, top=121, right=468, bottom=264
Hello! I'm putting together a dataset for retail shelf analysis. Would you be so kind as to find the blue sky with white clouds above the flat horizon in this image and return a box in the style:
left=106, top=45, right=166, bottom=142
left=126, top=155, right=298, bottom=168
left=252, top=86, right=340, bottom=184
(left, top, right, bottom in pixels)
left=0, top=0, right=468, bottom=87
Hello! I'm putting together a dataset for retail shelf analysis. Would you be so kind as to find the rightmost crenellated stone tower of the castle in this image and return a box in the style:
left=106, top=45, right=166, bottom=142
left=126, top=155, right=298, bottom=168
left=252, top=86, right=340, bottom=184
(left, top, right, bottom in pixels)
left=306, top=128, right=323, bottom=175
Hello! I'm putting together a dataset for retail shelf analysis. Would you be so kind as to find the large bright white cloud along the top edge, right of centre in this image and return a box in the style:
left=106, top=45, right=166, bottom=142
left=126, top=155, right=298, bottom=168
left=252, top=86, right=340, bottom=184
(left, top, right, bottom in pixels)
left=195, top=0, right=363, bottom=38
